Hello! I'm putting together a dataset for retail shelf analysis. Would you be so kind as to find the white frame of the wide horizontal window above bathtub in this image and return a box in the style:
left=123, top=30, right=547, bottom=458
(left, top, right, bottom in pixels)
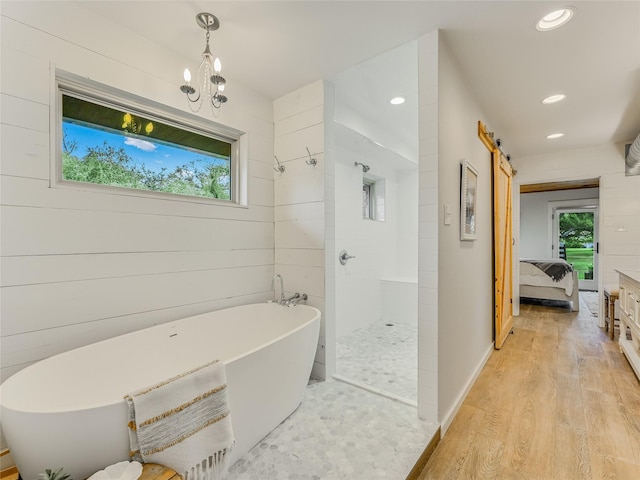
left=49, top=69, right=249, bottom=207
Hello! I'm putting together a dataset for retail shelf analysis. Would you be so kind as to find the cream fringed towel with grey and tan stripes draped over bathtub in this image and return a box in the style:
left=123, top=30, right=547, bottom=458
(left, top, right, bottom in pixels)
left=125, top=360, right=235, bottom=480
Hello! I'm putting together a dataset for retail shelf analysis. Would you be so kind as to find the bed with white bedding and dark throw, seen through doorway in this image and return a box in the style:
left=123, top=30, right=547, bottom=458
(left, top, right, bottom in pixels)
left=520, top=259, right=580, bottom=312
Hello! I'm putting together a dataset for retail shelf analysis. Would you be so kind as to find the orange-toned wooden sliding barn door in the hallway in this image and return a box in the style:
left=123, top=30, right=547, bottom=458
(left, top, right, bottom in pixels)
left=491, top=149, right=513, bottom=349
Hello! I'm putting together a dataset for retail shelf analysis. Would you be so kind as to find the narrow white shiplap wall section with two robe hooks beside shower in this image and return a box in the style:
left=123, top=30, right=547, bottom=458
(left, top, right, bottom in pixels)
left=273, top=81, right=327, bottom=379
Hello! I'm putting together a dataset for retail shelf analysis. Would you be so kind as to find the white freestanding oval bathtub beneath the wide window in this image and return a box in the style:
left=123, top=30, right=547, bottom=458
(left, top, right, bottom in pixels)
left=0, top=303, right=320, bottom=480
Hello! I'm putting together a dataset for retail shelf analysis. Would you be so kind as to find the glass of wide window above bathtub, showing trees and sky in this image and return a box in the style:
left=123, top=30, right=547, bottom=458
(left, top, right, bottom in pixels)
left=58, top=74, right=237, bottom=200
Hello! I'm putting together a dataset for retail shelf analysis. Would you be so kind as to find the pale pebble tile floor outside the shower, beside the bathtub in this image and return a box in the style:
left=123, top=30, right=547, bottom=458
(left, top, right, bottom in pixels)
left=227, top=379, right=437, bottom=480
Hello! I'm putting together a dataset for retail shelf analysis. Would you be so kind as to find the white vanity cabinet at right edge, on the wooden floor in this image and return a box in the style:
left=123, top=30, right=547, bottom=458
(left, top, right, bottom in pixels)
left=617, top=270, right=640, bottom=378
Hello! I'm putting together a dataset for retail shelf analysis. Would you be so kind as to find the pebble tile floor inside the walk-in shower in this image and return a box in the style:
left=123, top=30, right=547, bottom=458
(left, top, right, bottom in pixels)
left=336, top=320, right=418, bottom=404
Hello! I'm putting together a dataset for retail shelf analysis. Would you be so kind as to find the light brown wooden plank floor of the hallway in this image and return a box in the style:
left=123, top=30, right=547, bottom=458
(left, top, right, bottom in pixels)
left=418, top=296, right=640, bottom=480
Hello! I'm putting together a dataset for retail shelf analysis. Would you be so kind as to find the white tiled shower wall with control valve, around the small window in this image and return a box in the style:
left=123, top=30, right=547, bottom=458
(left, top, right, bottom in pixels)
left=333, top=125, right=418, bottom=337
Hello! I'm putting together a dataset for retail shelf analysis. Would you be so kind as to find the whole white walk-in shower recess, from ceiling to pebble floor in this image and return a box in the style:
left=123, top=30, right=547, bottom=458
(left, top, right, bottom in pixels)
left=332, top=42, right=419, bottom=405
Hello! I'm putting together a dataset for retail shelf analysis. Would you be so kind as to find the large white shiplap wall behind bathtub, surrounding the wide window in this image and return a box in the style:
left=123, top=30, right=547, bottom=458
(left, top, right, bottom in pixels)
left=0, top=2, right=274, bottom=379
